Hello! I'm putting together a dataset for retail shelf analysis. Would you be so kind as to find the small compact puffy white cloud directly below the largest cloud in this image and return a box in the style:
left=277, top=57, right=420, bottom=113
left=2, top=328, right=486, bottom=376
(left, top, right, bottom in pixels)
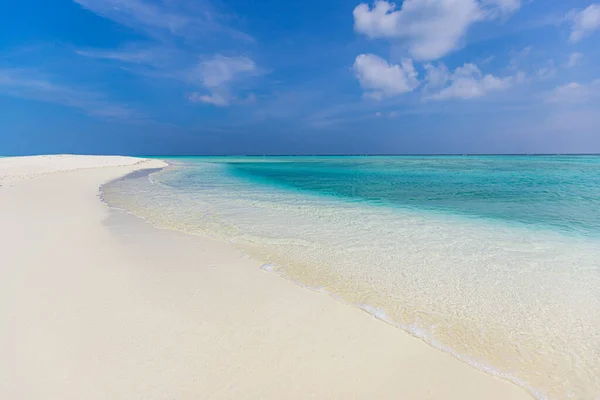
left=353, top=54, right=419, bottom=100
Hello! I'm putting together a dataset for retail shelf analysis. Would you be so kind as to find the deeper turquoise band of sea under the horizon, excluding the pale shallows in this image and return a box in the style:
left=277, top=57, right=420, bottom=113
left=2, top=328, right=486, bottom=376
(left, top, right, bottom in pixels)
left=210, top=156, right=600, bottom=235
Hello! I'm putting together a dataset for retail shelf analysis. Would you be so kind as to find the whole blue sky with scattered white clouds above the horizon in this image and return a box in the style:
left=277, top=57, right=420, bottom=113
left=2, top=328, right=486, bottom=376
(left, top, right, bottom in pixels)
left=0, top=0, right=600, bottom=155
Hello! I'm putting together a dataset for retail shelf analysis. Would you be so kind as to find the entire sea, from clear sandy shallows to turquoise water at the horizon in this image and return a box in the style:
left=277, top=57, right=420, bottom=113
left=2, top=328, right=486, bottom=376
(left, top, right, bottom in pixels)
left=104, top=156, right=600, bottom=399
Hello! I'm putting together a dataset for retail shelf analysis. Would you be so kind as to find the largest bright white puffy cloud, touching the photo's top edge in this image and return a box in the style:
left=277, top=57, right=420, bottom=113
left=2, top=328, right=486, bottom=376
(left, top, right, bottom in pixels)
left=353, top=0, right=520, bottom=60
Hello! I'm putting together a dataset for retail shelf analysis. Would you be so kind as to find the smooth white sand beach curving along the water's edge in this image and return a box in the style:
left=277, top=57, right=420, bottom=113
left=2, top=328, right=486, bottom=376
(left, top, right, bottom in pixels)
left=0, top=156, right=532, bottom=400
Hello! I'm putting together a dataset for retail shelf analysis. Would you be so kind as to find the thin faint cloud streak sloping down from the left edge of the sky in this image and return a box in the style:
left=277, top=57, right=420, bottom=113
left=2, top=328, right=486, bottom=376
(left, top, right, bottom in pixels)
left=0, top=69, right=137, bottom=119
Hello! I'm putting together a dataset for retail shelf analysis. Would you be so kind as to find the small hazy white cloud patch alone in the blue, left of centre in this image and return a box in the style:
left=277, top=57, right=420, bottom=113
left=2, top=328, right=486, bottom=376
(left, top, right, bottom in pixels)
left=187, top=54, right=260, bottom=106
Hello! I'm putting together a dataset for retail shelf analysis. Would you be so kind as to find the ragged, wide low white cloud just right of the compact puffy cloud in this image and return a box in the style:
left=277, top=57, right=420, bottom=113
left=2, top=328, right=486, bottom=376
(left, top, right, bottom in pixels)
left=425, top=64, right=522, bottom=100
